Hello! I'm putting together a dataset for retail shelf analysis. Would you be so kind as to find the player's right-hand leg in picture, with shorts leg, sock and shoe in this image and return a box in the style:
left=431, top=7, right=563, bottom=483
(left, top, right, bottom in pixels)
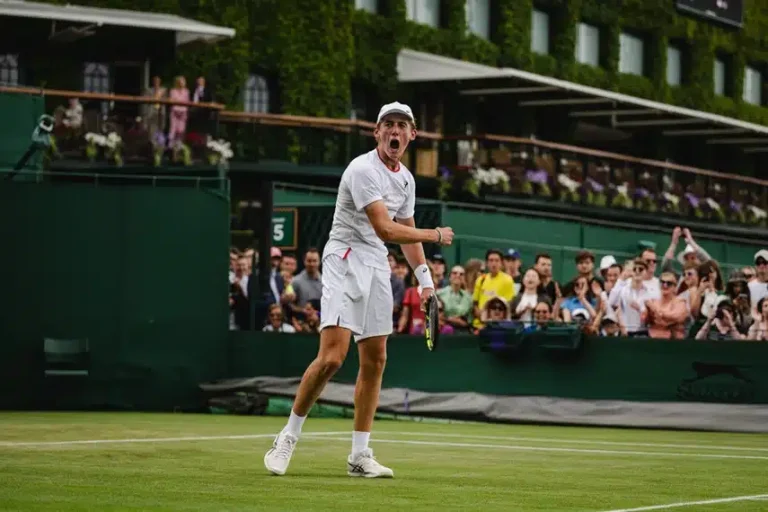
left=347, top=271, right=393, bottom=478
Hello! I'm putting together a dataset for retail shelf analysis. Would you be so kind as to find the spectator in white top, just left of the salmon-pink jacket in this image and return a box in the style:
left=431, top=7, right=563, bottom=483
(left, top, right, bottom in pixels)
left=608, top=258, right=658, bottom=336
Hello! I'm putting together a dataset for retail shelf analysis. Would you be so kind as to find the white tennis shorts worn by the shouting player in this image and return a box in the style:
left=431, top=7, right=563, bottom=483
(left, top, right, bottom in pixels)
left=320, top=250, right=392, bottom=342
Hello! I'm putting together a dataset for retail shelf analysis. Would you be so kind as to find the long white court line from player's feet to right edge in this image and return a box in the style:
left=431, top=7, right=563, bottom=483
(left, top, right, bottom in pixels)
left=298, top=437, right=768, bottom=460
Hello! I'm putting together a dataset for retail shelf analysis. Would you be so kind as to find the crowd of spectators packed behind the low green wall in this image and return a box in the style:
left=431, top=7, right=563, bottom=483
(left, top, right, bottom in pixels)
left=229, top=227, right=768, bottom=341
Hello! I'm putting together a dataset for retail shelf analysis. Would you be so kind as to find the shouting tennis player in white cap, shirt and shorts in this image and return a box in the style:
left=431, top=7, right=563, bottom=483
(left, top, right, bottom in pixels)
left=264, top=102, right=453, bottom=478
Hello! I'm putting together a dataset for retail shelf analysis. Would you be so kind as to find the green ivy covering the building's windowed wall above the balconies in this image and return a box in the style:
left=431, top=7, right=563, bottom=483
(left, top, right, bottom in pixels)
left=28, top=0, right=768, bottom=124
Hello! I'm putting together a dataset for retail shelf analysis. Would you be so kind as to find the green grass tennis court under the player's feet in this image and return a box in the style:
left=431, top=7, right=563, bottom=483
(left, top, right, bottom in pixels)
left=0, top=412, right=768, bottom=512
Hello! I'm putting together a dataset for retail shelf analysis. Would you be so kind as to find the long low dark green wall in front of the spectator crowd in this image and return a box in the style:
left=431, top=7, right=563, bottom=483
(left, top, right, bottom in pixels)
left=230, top=332, right=768, bottom=404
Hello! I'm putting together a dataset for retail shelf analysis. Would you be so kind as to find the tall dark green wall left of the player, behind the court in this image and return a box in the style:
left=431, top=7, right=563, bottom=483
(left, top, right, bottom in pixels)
left=0, top=178, right=229, bottom=410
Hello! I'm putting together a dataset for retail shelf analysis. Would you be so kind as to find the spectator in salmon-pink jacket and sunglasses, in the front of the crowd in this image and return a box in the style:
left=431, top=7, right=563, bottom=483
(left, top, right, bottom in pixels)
left=641, top=272, right=689, bottom=340
